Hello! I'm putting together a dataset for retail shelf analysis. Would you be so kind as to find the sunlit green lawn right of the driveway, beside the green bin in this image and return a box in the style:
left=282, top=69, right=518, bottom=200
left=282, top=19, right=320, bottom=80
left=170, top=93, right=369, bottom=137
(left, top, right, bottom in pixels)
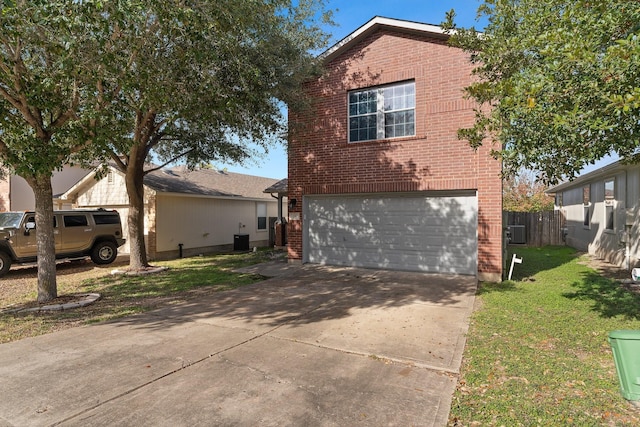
left=449, top=247, right=640, bottom=426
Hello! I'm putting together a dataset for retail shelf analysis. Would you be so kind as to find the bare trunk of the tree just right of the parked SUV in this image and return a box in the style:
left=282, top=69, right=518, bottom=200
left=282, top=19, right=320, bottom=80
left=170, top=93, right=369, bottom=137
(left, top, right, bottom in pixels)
left=125, top=148, right=149, bottom=270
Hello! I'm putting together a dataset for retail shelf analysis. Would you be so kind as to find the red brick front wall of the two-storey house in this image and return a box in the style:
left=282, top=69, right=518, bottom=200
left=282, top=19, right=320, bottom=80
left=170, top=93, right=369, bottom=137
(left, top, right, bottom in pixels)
left=288, top=31, right=502, bottom=279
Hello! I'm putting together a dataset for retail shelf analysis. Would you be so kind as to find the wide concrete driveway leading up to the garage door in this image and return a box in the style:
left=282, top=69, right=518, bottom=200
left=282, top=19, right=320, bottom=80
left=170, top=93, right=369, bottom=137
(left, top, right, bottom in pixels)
left=0, top=263, right=476, bottom=426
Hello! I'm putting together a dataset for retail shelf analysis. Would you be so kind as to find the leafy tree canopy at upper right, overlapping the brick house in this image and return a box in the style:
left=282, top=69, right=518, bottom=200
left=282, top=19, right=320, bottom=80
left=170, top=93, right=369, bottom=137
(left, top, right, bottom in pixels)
left=444, top=0, right=640, bottom=183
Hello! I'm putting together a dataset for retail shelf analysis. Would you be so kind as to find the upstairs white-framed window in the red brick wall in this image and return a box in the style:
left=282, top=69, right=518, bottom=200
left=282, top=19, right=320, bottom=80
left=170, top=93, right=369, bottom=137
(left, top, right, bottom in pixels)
left=349, top=82, right=416, bottom=142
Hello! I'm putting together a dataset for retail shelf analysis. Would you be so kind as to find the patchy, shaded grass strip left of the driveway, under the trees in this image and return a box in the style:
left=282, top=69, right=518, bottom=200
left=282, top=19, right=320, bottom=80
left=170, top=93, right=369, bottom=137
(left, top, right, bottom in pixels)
left=0, top=250, right=280, bottom=343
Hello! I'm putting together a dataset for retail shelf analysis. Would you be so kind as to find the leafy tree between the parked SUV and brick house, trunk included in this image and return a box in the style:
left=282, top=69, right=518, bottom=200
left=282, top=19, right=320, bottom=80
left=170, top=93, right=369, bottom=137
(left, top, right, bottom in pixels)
left=96, top=0, right=330, bottom=270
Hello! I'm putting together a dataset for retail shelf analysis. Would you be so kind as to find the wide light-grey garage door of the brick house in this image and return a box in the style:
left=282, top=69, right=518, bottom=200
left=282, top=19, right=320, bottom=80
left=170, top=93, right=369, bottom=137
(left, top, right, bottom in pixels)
left=303, top=192, right=478, bottom=275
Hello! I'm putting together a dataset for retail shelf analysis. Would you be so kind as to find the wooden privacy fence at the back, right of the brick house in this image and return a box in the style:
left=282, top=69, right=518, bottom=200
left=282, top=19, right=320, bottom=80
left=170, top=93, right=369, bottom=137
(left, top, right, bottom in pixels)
left=504, top=211, right=565, bottom=246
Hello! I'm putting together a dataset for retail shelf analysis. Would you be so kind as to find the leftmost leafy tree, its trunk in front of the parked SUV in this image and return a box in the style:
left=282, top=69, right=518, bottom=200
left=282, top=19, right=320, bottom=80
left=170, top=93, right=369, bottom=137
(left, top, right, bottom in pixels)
left=0, top=0, right=111, bottom=301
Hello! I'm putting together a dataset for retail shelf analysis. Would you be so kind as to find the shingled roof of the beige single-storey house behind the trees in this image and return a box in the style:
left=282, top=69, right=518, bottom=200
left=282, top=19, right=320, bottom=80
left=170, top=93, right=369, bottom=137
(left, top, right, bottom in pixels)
left=144, top=166, right=278, bottom=199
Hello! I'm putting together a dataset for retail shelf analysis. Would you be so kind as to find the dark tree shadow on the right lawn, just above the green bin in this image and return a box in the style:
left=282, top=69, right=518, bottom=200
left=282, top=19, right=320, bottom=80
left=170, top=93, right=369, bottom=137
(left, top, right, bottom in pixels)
left=563, top=272, right=640, bottom=320
